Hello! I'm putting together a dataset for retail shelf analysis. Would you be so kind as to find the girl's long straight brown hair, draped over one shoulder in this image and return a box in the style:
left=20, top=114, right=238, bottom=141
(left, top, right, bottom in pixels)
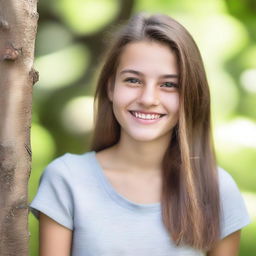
left=91, top=14, right=220, bottom=251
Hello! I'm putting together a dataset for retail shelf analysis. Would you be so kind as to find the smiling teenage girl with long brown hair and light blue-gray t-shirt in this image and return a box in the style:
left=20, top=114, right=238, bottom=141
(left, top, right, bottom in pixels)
left=30, top=14, right=249, bottom=256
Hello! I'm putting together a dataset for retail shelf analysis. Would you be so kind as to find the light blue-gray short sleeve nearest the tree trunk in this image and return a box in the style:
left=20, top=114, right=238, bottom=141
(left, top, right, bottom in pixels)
left=30, top=156, right=73, bottom=230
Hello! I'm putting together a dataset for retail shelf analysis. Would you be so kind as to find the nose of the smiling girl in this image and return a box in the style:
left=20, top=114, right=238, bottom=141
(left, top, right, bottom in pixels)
left=138, top=84, right=159, bottom=106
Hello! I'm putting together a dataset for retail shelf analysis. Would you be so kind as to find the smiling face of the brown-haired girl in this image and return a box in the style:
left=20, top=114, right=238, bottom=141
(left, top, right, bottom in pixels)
left=108, top=41, right=179, bottom=141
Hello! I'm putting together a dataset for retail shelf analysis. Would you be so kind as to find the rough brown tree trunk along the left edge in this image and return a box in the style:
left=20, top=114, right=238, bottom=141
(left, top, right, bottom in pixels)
left=0, top=0, right=38, bottom=256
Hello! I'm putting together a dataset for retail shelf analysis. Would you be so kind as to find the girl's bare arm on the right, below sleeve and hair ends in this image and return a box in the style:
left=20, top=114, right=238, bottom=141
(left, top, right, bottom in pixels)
left=207, top=230, right=241, bottom=256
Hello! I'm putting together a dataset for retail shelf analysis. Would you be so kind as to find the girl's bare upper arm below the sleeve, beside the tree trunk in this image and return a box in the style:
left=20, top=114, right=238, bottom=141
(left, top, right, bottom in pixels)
left=39, top=213, right=72, bottom=256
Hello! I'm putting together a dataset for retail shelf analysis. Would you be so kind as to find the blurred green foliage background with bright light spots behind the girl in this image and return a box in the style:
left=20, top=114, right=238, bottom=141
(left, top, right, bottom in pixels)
left=29, top=0, right=256, bottom=256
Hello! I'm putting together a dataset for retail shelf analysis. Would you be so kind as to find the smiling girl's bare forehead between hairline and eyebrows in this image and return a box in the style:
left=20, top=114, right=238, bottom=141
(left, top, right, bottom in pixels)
left=117, top=41, right=178, bottom=74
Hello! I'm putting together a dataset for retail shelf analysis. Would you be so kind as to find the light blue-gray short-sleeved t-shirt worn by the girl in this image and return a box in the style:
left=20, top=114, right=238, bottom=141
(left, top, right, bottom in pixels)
left=30, top=151, right=250, bottom=256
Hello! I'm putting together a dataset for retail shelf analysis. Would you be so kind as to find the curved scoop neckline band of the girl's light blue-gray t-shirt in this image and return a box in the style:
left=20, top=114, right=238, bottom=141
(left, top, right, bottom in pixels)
left=88, top=151, right=161, bottom=212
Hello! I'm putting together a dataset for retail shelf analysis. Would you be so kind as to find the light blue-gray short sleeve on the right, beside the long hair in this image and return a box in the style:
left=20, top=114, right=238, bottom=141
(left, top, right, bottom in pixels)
left=219, top=168, right=250, bottom=238
